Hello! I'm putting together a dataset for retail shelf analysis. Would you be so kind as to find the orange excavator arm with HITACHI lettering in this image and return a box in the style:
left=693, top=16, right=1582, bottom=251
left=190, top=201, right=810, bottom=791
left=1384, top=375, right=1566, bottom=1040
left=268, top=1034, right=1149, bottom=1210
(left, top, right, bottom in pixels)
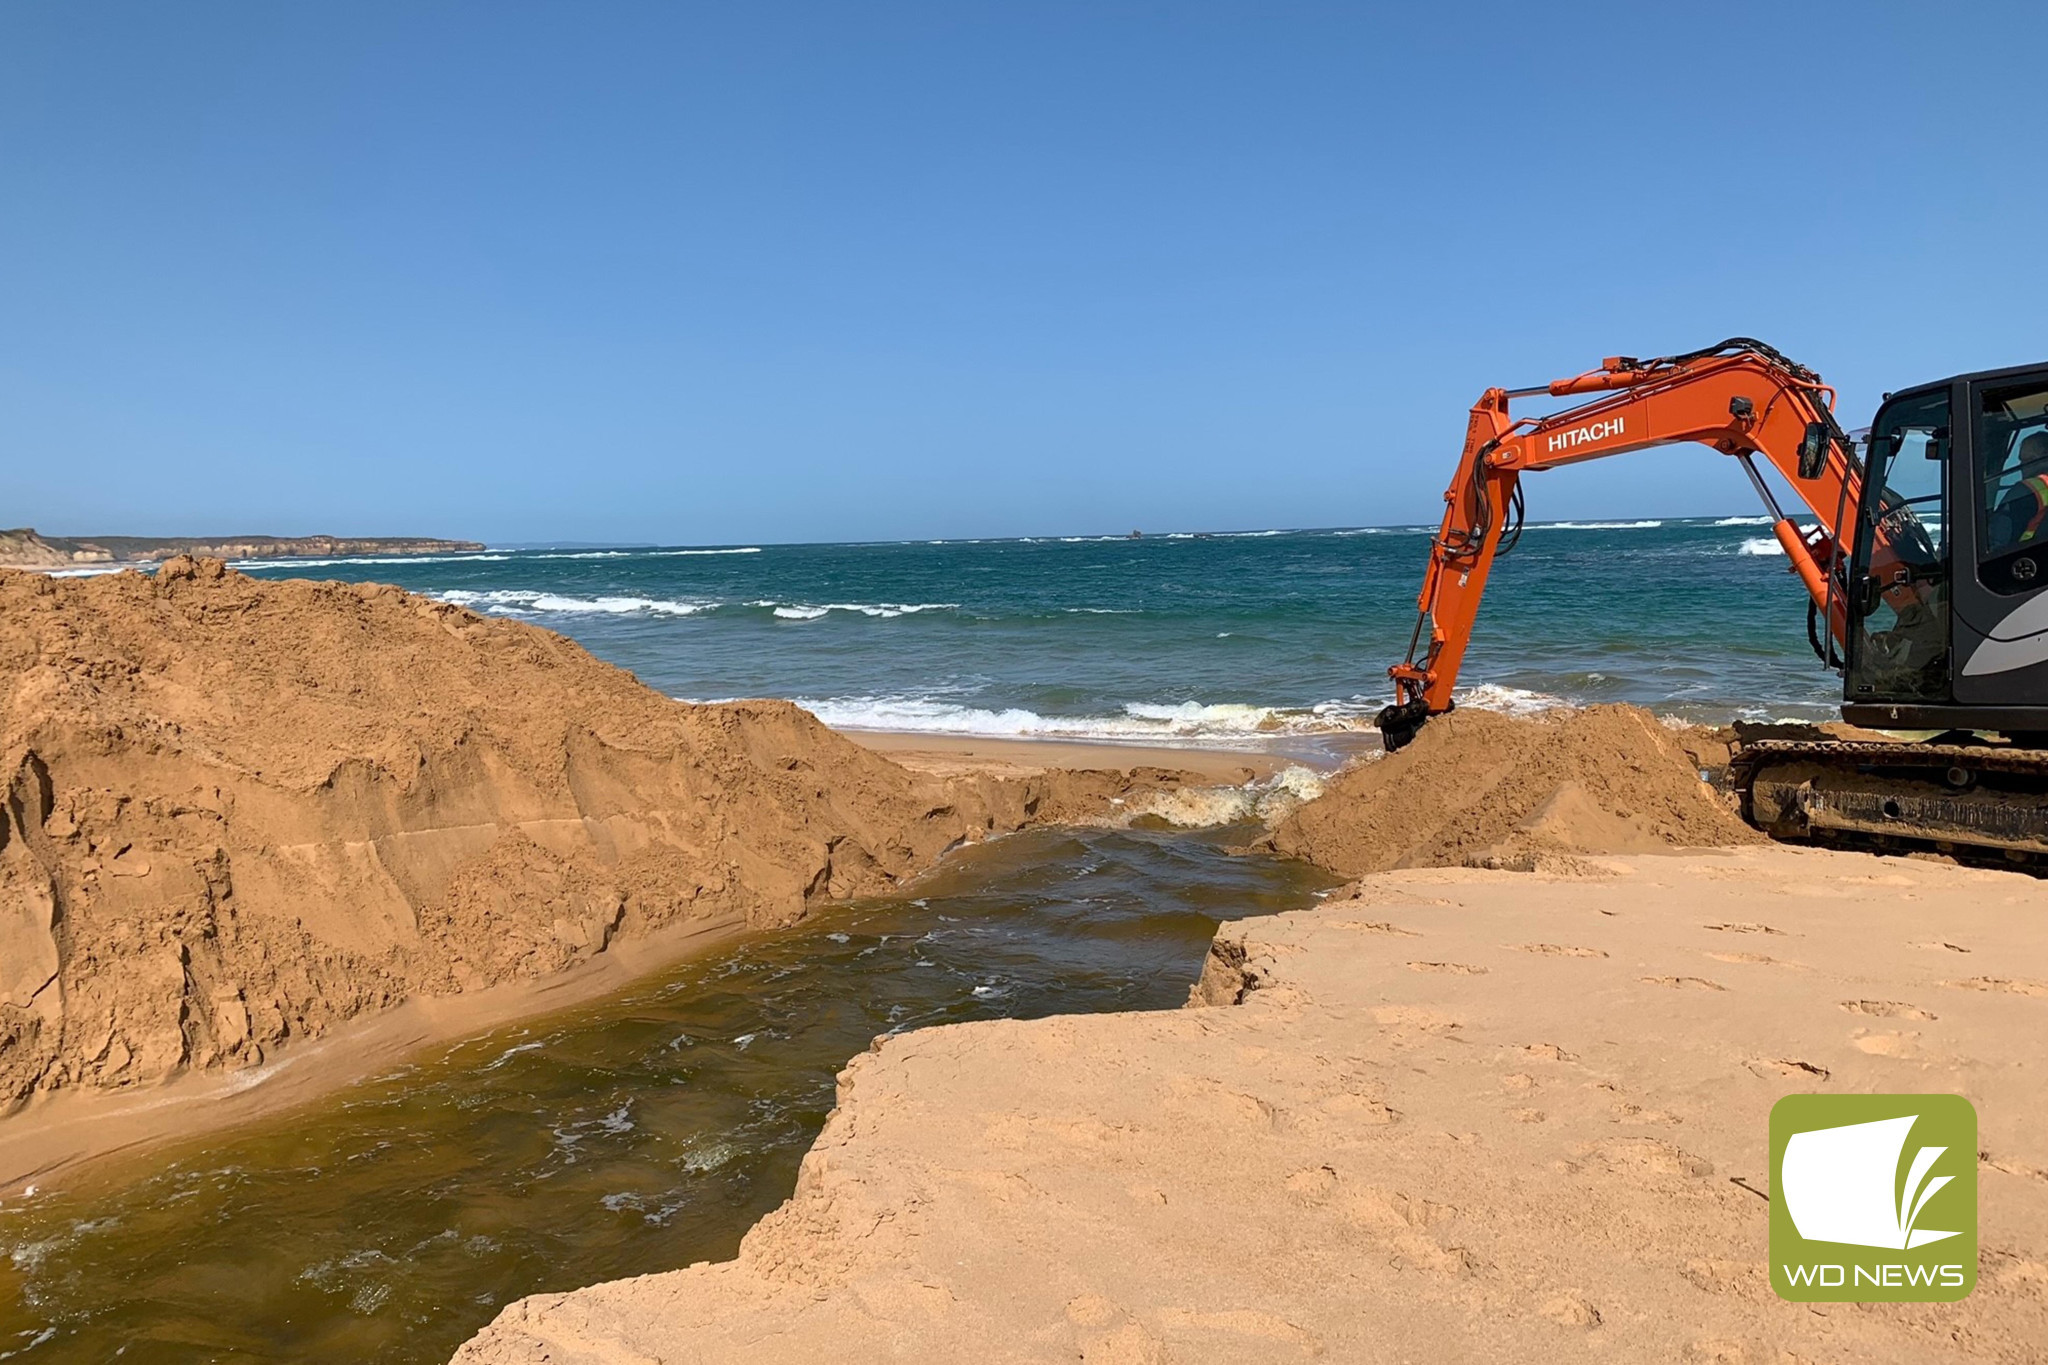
left=1378, top=338, right=1862, bottom=749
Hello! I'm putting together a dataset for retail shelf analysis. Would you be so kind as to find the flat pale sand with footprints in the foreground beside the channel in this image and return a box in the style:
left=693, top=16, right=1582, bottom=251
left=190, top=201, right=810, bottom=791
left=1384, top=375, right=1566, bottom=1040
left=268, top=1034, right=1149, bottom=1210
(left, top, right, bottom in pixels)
left=457, top=847, right=2048, bottom=1365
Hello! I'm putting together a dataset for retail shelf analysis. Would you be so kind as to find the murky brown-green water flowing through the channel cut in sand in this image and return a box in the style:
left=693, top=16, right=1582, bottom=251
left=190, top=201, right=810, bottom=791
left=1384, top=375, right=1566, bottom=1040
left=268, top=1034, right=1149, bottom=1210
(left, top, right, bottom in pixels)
left=0, top=829, right=1329, bottom=1365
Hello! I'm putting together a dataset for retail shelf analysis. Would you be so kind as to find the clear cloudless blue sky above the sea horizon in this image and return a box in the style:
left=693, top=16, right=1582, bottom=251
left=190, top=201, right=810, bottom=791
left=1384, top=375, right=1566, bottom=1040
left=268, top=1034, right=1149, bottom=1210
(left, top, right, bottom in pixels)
left=0, top=0, right=2048, bottom=542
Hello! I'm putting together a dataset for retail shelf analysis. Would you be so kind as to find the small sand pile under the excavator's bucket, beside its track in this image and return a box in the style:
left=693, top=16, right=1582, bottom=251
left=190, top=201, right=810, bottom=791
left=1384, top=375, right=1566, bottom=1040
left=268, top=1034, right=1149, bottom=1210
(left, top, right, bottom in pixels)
left=1272, top=706, right=1761, bottom=876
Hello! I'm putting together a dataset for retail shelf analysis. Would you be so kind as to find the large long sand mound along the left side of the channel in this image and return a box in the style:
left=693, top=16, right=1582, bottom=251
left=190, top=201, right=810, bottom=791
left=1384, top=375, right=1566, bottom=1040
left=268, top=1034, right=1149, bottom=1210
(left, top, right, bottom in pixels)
left=0, top=559, right=1174, bottom=1109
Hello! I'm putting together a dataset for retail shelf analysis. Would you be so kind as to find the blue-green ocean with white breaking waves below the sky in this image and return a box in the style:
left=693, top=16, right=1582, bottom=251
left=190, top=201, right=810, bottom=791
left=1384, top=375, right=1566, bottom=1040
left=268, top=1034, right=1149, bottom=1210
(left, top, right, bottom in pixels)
left=238, top=518, right=1839, bottom=747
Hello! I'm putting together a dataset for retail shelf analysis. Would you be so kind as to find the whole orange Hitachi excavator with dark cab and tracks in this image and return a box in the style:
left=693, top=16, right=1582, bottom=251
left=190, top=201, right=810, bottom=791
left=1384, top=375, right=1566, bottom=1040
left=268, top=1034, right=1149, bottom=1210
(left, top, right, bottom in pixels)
left=1378, top=338, right=2048, bottom=870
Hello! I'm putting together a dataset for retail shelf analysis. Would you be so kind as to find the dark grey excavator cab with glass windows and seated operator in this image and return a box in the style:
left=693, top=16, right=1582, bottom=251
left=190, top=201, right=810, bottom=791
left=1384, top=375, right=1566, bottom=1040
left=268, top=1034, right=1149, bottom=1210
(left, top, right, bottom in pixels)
left=1843, top=366, right=2048, bottom=743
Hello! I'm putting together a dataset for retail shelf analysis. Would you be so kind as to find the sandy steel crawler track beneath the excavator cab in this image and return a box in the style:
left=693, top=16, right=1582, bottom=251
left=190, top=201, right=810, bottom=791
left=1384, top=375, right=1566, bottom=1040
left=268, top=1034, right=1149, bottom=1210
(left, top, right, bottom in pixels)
left=1729, top=739, right=2048, bottom=874
